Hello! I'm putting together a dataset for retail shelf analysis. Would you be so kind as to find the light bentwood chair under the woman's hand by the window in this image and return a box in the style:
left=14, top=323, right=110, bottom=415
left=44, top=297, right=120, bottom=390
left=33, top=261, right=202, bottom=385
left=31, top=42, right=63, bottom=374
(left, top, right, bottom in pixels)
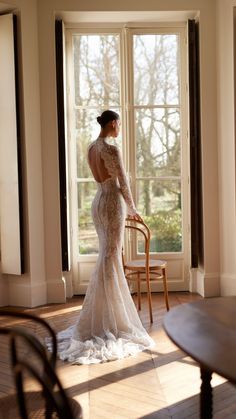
left=122, top=218, right=169, bottom=323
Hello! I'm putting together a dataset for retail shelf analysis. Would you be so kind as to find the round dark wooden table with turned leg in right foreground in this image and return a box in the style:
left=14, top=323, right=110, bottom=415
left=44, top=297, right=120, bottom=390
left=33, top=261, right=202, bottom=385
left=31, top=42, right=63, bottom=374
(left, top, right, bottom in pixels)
left=164, top=297, right=236, bottom=419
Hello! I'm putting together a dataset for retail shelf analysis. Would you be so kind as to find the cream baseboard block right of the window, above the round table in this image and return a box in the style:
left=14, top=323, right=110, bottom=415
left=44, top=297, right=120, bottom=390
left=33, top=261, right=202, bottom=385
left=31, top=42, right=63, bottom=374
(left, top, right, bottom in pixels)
left=190, top=268, right=221, bottom=297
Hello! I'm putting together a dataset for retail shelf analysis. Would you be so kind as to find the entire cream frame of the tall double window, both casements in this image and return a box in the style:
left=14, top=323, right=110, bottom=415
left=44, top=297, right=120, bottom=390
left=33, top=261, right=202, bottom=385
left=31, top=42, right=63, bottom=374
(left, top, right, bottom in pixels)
left=65, top=22, right=190, bottom=263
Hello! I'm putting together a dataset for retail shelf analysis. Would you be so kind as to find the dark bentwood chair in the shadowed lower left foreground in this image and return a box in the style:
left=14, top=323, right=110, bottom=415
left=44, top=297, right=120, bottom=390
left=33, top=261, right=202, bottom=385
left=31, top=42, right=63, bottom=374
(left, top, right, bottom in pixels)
left=0, top=310, right=82, bottom=419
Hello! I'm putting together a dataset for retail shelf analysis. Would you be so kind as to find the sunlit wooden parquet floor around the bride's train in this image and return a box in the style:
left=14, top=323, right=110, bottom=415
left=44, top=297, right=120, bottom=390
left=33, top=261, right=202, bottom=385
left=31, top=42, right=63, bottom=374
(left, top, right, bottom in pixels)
left=0, top=293, right=236, bottom=419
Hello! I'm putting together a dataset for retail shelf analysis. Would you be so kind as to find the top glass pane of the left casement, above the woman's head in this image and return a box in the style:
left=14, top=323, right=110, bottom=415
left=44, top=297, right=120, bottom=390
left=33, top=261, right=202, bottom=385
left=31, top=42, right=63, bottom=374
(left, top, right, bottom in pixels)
left=73, top=35, right=120, bottom=108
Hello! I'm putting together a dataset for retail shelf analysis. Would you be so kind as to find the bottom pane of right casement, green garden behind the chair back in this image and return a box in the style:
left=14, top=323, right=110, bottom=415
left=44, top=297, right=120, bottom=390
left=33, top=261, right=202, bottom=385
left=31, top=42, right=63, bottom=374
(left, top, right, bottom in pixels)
left=137, top=180, right=182, bottom=253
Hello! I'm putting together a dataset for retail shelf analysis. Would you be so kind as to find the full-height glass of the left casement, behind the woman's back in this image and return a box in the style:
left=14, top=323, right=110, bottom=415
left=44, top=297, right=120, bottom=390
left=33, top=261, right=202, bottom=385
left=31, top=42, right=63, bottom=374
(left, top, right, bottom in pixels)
left=67, top=33, right=121, bottom=255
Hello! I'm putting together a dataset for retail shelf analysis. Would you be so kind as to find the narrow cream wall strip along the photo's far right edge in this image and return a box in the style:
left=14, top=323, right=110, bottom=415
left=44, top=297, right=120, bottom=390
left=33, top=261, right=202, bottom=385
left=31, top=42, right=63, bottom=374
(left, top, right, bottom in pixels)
left=217, top=0, right=236, bottom=295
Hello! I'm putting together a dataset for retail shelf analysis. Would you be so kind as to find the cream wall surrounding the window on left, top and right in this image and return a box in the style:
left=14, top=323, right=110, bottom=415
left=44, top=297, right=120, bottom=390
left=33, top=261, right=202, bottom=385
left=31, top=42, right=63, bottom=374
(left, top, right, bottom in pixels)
left=0, top=0, right=220, bottom=306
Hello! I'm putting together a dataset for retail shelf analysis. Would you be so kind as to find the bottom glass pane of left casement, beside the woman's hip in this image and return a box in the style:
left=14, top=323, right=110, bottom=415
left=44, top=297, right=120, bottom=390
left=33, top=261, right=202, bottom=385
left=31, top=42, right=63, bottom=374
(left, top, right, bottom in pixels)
left=78, top=182, right=98, bottom=255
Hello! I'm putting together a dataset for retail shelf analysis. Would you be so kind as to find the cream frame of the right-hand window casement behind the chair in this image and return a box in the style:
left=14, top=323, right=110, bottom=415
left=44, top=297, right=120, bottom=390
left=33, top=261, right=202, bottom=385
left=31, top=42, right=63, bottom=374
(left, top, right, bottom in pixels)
left=125, top=26, right=190, bottom=259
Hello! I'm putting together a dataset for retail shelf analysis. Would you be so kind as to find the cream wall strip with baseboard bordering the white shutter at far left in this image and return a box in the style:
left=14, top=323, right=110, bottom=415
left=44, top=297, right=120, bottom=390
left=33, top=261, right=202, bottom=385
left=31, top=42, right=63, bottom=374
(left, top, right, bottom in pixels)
left=0, top=0, right=46, bottom=307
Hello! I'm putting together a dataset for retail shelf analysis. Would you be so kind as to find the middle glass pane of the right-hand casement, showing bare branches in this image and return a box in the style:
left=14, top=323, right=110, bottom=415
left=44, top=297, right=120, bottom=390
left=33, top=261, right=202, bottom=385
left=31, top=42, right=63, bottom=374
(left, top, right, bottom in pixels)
left=135, top=108, right=181, bottom=177
